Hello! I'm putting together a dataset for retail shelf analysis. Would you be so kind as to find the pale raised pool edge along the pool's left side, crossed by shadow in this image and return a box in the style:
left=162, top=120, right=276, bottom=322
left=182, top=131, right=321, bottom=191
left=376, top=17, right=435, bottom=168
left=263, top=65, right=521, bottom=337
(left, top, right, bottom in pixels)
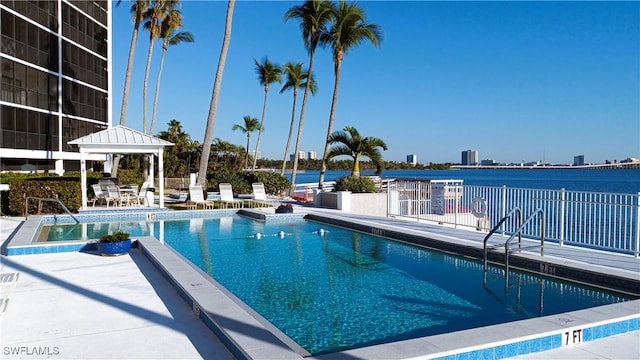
left=138, top=236, right=303, bottom=360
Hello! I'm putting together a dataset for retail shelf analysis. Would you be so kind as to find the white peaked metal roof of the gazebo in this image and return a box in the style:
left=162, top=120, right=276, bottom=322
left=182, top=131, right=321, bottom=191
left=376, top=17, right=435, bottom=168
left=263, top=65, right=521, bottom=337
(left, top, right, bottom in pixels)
left=68, top=125, right=173, bottom=153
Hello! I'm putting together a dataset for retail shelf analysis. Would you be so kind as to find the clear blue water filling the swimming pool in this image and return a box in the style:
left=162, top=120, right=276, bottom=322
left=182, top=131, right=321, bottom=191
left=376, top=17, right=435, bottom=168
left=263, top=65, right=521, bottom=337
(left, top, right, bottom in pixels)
left=43, top=216, right=628, bottom=355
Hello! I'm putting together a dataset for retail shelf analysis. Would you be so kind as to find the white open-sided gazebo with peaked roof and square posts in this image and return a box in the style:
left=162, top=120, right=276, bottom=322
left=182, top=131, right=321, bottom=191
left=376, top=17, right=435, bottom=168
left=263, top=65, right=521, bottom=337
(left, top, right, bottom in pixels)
left=69, top=125, right=173, bottom=210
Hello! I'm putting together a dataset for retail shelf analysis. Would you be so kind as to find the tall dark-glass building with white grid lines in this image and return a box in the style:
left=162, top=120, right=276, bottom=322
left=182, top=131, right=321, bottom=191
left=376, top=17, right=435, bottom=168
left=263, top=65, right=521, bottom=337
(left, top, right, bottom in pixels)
left=0, top=0, right=111, bottom=173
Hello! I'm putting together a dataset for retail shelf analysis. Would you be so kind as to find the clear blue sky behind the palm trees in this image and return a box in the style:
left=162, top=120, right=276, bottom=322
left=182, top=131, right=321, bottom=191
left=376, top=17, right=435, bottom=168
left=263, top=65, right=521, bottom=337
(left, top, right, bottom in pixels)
left=113, top=0, right=640, bottom=163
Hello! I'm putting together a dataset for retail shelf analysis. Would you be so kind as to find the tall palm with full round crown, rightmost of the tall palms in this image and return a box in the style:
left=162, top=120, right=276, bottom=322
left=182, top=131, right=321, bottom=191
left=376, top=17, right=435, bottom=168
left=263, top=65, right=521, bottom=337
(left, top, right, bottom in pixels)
left=318, top=0, right=382, bottom=189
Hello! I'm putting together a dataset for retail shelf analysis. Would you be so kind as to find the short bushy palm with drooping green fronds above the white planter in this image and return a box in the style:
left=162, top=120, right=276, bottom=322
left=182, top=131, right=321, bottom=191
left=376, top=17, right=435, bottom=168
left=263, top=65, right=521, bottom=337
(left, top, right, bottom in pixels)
left=327, top=126, right=387, bottom=177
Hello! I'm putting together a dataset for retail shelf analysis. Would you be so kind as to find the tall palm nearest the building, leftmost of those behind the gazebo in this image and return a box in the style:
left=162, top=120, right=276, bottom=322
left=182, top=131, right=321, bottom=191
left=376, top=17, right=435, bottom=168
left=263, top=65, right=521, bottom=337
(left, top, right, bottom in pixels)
left=111, top=0, right=150, bottom=177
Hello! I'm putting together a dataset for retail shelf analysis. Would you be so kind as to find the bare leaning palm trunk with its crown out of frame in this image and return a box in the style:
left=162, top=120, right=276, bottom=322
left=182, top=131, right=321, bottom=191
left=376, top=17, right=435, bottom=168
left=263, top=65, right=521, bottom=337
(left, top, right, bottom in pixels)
left=197, top=0, right=236, bottom=187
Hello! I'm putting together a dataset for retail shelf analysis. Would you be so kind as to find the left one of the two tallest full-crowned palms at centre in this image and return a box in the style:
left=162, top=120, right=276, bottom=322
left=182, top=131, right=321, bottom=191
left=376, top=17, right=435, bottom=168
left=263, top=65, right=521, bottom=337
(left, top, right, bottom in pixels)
left=284, top=0, right=335, bottom=194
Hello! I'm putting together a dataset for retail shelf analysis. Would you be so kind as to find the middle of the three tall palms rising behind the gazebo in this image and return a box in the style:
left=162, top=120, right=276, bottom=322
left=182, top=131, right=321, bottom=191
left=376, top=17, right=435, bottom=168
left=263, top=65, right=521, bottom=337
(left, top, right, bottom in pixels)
left=142, top=0, right=180, bottom=134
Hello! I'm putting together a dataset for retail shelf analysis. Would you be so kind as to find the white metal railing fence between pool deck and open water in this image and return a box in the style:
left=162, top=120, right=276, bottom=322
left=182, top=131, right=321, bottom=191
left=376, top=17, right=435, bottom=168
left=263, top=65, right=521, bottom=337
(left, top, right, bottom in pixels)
left=387, top=180, right=640, bottom=257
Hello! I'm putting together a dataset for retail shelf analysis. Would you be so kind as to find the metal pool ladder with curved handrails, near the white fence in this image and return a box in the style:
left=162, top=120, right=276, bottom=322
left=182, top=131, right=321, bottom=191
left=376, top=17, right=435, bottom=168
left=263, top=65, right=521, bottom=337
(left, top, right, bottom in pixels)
left=483, top=207, right=544, bottom=287
